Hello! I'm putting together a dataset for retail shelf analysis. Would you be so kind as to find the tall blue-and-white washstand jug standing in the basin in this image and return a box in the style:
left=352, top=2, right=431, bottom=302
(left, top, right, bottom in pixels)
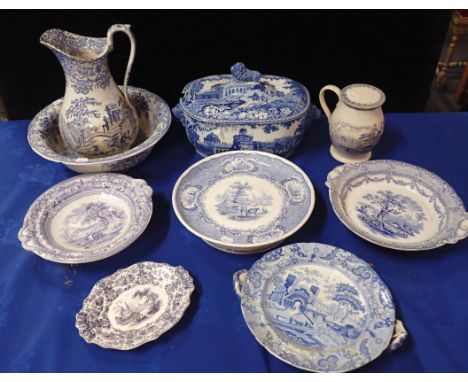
left=40, top=24, right=138, bottom=158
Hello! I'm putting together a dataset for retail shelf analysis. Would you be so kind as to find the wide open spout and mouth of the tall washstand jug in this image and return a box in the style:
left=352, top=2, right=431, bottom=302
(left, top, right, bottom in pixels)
left=39, top=28, right=109, bottom=61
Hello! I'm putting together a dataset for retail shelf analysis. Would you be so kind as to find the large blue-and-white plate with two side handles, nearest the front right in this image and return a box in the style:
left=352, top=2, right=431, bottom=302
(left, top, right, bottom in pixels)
left=234, top=243, right=407, bottom=372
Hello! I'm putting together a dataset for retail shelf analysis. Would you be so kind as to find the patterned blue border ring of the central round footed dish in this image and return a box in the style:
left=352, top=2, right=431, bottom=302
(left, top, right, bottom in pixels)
left=174, top=151, right=314, bottom=245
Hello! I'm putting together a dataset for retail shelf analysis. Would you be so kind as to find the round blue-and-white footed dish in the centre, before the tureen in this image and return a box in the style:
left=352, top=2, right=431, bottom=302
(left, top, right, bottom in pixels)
left=172, top=151, right=315, bottom=254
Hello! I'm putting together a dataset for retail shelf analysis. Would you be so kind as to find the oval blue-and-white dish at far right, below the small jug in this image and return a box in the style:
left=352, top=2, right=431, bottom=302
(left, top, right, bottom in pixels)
left=326, top=160, right=468, bottom=251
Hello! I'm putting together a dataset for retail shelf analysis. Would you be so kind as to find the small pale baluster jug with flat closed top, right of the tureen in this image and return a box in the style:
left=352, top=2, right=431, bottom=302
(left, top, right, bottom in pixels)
left=319, top=84, right=385, bottom=163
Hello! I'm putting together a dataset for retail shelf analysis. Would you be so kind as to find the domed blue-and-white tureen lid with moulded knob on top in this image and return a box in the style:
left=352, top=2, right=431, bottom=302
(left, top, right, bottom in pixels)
left=180, top=62, right=310, bottom=123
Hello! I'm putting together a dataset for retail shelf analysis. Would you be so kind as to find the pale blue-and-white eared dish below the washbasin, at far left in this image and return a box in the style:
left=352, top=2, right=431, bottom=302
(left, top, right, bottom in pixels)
left=18, top=173, right=153, bottom=264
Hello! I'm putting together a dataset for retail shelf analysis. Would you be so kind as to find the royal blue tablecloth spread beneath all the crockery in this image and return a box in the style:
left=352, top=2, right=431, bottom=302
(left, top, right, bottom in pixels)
left=0, top=113, right=468, bottom=372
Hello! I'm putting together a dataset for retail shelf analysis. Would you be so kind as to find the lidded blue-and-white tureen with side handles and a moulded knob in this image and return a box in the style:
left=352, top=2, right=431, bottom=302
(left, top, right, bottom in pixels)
left=172, top=63, right=319, bottom=156
